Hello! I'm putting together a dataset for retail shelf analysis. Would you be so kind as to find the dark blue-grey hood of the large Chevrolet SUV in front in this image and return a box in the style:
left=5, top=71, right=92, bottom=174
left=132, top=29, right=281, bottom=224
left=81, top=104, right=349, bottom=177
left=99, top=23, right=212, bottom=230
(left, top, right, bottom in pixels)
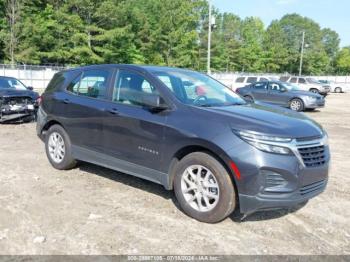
left=203, top=103, right=324, bottom=138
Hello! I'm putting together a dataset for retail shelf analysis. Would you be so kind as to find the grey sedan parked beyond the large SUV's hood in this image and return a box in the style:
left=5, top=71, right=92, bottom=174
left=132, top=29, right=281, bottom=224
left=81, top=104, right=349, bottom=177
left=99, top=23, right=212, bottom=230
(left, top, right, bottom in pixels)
left=236, top=81, right=325, bottom=112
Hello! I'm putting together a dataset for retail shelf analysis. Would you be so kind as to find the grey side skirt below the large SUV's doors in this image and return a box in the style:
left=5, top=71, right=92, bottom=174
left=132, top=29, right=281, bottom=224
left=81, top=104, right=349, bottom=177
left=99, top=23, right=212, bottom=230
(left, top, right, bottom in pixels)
left=72, top=145, right=169, bottom=189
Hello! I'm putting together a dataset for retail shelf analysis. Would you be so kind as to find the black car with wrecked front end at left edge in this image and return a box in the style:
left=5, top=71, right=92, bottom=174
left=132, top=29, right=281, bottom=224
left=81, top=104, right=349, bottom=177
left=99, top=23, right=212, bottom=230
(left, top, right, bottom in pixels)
left=0, top=76, right=39, bottom=123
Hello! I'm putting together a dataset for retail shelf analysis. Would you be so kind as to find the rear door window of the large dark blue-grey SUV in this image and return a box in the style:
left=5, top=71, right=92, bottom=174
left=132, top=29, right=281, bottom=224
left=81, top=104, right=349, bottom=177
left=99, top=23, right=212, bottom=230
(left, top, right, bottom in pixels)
left=67, top=70, right=110, bottom=99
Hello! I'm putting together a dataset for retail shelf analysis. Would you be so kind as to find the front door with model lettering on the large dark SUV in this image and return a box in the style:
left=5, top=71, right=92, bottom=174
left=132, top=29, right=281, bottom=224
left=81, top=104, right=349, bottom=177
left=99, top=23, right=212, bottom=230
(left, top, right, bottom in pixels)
left=104, top=69, right=168, bottom=171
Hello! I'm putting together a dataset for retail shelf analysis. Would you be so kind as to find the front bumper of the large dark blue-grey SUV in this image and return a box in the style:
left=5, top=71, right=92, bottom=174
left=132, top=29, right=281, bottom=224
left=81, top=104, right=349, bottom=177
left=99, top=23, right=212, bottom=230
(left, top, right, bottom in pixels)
left=230, top=137, right=330, bottom=214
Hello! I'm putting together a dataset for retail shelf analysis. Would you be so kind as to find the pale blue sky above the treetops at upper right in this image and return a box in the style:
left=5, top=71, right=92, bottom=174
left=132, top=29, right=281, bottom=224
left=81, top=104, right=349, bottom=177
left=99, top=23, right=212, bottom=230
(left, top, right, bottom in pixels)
left=212, top=0, right=350, bottom=47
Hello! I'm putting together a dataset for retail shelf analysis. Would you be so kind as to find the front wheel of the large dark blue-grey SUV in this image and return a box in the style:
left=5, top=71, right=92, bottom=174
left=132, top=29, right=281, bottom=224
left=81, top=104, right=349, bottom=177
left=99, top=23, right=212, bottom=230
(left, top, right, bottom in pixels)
left=174, top=152, right=236, bottom=223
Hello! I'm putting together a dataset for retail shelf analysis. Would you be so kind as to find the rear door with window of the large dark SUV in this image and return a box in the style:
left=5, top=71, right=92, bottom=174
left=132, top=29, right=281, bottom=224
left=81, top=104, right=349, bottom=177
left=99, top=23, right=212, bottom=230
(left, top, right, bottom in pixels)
left=57, top=68, right=112, bottom=152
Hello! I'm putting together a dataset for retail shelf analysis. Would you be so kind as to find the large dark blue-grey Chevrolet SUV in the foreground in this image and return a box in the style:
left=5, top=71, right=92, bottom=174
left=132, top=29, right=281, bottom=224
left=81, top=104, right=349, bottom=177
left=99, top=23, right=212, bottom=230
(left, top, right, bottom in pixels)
left=37, top=65, right=330, bottom=223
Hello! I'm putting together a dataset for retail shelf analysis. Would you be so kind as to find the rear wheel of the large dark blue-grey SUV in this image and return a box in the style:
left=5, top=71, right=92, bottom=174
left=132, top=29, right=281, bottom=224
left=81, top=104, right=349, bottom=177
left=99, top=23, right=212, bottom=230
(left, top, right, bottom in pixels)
left=45, top=125, right=77, bottom=170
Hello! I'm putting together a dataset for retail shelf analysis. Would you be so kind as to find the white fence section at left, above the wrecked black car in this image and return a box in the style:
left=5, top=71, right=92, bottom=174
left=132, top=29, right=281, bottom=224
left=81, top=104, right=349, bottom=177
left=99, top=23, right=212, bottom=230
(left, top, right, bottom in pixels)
left=0, top=64, right=65, bottom=92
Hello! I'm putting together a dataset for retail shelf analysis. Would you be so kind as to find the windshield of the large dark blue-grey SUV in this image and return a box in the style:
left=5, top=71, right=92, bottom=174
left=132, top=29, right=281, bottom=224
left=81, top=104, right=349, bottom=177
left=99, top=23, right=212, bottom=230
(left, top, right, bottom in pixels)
left=153, top=69, right=246, bottom=107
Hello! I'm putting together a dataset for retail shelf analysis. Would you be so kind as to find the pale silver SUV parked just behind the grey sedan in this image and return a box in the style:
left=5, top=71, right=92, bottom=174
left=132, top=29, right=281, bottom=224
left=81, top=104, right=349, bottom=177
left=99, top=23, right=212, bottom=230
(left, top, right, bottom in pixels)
left=280, top=76, right=330, bottom=96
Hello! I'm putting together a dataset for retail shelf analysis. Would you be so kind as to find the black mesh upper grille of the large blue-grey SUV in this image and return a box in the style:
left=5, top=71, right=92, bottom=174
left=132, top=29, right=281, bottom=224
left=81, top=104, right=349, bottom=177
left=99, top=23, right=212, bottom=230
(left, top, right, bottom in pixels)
left=298, top=146, right=326, bottom=167
